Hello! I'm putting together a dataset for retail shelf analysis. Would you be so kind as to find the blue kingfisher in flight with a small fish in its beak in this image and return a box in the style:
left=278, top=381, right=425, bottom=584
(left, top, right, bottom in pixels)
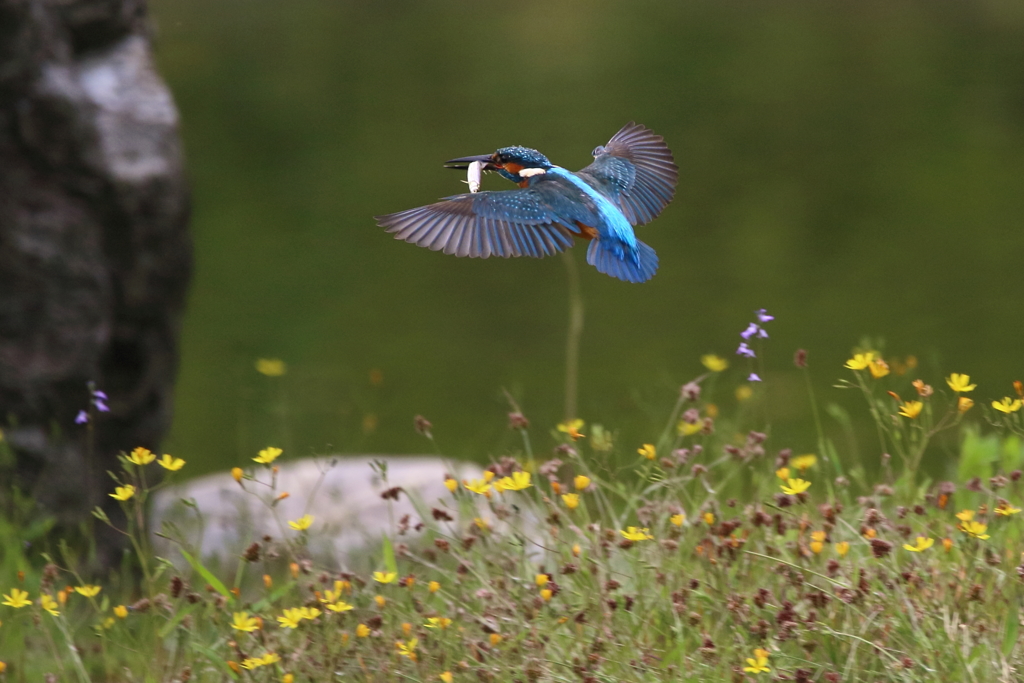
left=375, top=122, right=679, bottom=283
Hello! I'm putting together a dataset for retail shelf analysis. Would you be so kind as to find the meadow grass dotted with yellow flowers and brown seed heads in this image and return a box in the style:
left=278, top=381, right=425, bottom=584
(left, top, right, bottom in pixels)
left=0, top=350, right=1024, bottom=683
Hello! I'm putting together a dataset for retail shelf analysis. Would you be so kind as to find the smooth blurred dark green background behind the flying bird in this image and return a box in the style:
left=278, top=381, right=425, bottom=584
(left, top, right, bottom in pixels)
left=152, top=0, right=1024, bottom=473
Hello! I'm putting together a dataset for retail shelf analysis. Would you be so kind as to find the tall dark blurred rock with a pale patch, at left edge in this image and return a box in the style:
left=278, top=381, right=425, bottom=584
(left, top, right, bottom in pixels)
left=0, top=0, right=191, bottom=561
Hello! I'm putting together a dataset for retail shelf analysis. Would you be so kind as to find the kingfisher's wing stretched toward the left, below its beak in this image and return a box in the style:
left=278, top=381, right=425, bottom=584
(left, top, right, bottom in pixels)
left=376, top=187, right=585, bottom=258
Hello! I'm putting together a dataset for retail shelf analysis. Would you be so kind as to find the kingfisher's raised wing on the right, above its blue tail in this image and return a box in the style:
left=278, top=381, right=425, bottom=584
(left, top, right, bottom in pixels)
left=577, top=122, right=679, bottom=225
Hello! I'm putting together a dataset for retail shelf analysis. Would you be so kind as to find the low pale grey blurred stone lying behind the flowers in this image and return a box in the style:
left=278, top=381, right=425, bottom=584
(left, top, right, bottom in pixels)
left=151, top=456, right=487, bottom=564
